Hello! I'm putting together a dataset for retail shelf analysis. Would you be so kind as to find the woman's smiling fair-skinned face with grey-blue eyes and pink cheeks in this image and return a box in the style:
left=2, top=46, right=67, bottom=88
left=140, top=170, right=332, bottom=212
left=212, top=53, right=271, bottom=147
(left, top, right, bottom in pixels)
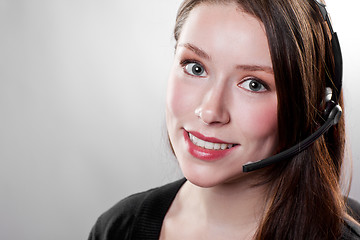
left=166, top=4, right=278, bottom=187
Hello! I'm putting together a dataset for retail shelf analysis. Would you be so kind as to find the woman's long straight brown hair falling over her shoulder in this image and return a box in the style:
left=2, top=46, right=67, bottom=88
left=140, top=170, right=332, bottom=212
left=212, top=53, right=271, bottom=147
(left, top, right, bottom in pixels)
left=174, top=0, right=347, bottom=239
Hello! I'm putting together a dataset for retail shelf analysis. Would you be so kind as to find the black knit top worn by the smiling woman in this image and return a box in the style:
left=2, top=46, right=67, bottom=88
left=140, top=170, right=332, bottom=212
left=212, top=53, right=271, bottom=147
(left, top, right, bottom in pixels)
left=89, top=179, right=360, bottom=240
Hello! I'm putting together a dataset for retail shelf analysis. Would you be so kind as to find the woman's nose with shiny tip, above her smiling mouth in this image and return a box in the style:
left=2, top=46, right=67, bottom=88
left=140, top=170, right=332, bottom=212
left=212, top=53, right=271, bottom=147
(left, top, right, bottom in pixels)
left=195, top=88, right=230, bottom=125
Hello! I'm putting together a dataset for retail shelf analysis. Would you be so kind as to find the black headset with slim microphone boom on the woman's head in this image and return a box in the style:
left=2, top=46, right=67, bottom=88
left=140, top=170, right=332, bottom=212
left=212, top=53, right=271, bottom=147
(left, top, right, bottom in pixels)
left=243, top=0, right=343, bottom=172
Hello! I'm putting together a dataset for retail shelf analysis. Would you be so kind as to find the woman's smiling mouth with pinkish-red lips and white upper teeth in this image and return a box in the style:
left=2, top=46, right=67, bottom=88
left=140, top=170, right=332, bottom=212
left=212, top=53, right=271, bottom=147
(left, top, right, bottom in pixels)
left=183, top=129, right=238, bottom=161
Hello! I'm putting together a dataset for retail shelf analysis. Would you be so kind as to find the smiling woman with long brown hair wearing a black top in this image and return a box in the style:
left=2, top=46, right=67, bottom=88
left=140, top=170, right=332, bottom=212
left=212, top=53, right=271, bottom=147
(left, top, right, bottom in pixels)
left=89, top=0, right=360, bottom=239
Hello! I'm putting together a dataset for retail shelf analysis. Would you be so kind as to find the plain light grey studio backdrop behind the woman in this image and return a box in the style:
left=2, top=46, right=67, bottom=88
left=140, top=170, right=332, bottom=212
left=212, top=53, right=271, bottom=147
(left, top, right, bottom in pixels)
left=0, top=0, right=360, bottom=240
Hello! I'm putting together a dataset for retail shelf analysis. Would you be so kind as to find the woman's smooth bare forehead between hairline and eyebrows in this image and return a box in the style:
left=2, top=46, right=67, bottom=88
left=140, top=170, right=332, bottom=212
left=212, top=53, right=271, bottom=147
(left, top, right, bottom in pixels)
left=178, top=4, right=272, bottom=70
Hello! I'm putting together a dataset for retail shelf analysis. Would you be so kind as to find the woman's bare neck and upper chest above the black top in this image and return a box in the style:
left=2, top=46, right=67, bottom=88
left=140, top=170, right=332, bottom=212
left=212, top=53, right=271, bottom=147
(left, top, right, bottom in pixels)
left=167, top=175, right=267, bottom=239
